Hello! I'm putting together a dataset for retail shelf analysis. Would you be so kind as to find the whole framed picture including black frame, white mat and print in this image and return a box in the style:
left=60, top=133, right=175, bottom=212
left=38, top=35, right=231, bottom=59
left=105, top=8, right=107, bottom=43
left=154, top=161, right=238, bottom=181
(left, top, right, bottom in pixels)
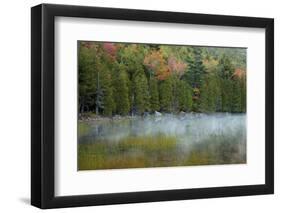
left=31, top=4, right=274, bottom=208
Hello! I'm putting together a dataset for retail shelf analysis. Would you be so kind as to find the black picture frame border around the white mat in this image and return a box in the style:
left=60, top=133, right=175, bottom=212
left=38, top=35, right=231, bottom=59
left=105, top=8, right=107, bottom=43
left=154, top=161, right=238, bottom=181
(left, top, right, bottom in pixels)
left=31, top=4, right=274, bottom=209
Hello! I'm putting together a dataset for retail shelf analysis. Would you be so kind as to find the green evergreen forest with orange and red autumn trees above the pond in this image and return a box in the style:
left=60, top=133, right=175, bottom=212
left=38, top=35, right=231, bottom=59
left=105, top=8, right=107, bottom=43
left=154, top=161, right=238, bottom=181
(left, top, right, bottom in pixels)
left=78, top=41, right=247, bottom=116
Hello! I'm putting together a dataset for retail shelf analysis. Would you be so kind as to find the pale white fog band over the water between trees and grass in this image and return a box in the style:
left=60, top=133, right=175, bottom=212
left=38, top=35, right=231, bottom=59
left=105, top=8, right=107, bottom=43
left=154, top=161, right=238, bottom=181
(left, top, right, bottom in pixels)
left=79, top=113, right=246, bottom=144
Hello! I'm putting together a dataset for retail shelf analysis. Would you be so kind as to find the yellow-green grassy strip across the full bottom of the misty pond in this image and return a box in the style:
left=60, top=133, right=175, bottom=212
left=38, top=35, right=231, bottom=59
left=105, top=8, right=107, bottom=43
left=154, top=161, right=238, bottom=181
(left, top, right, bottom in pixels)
left=78, top=134, right=246, bottom=170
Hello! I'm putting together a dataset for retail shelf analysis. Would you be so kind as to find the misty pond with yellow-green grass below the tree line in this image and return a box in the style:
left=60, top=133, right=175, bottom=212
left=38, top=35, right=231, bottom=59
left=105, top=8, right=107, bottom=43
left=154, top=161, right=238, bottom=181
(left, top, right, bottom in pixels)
left=78, top=113, right=246, bottom=170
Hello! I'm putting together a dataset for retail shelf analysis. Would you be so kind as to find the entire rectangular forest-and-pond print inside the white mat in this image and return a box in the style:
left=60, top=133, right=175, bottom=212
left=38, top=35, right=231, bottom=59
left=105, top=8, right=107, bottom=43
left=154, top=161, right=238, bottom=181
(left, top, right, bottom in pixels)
left=77, top=41, right=247, bottom=170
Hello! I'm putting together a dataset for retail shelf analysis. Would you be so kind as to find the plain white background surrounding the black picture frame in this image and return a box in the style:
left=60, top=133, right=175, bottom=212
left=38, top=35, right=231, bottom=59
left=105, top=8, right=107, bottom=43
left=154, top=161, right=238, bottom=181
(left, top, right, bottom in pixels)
left=0, top=0, right=276, bottom=213
